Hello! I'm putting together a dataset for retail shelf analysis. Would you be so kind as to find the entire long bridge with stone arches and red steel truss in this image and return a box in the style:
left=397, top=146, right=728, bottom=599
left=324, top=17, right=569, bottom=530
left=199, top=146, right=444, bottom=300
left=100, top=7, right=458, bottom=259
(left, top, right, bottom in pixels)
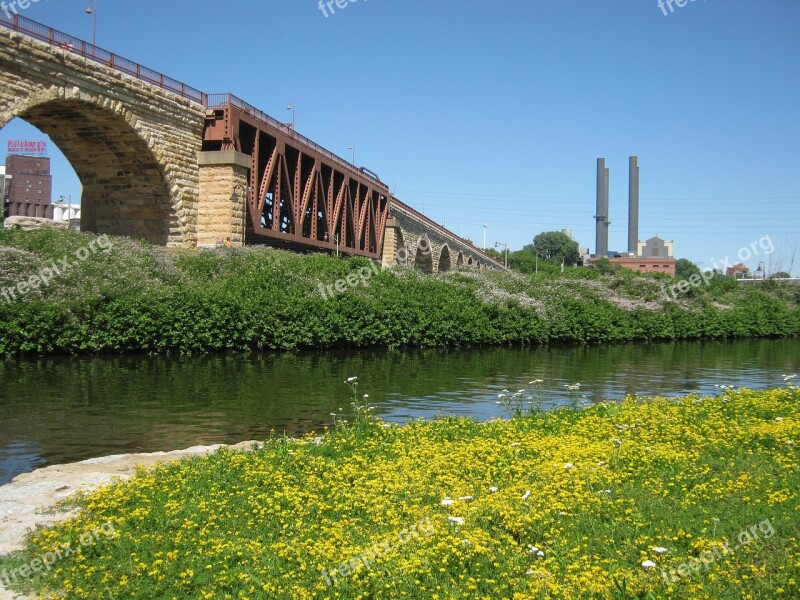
left=0, top=14, right=503, bottom=273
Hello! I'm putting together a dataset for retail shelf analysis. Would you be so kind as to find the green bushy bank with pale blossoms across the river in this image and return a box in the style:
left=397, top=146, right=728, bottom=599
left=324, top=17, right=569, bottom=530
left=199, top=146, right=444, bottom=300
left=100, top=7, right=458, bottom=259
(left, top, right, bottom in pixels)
left=0, top=230, right=800, bottom=355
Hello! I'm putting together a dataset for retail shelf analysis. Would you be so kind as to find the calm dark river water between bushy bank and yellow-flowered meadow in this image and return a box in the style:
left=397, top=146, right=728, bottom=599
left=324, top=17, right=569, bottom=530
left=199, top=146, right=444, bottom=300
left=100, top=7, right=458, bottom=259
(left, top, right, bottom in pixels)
left=0, top=339, right=800, bottom=484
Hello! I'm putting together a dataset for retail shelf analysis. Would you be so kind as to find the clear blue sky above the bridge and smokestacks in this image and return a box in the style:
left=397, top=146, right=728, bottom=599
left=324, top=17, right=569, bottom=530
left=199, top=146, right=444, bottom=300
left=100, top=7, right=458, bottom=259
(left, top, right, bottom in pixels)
left=0, top=0, right=800, bottom=273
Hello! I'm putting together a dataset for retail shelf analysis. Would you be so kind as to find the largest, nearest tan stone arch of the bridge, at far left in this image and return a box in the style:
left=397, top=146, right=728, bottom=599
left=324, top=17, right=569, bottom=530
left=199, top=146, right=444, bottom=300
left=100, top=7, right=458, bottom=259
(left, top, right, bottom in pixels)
left=0, top=28, right=205, bottom=246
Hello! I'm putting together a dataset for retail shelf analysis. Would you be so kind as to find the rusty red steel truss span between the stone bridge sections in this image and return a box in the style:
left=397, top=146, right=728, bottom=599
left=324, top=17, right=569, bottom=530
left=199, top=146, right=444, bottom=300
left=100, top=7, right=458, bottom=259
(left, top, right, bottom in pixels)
left=203, top=104, right=389, bottom=260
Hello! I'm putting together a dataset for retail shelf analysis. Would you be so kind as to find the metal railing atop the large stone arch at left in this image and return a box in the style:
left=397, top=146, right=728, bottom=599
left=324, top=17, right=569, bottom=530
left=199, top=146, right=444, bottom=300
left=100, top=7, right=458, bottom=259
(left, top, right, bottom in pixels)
left=0, top=11, right=208, bottom=106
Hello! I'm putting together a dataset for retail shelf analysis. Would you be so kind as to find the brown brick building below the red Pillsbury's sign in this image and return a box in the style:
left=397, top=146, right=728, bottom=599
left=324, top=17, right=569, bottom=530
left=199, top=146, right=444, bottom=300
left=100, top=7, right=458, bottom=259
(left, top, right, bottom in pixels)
left=5, top=154, right=53, bottom=219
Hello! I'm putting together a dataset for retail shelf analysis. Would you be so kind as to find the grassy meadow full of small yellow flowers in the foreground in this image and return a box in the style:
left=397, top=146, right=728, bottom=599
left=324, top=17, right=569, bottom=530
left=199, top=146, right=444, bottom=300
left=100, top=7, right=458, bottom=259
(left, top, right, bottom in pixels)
left=0, top=376, right=800, bottom=600
